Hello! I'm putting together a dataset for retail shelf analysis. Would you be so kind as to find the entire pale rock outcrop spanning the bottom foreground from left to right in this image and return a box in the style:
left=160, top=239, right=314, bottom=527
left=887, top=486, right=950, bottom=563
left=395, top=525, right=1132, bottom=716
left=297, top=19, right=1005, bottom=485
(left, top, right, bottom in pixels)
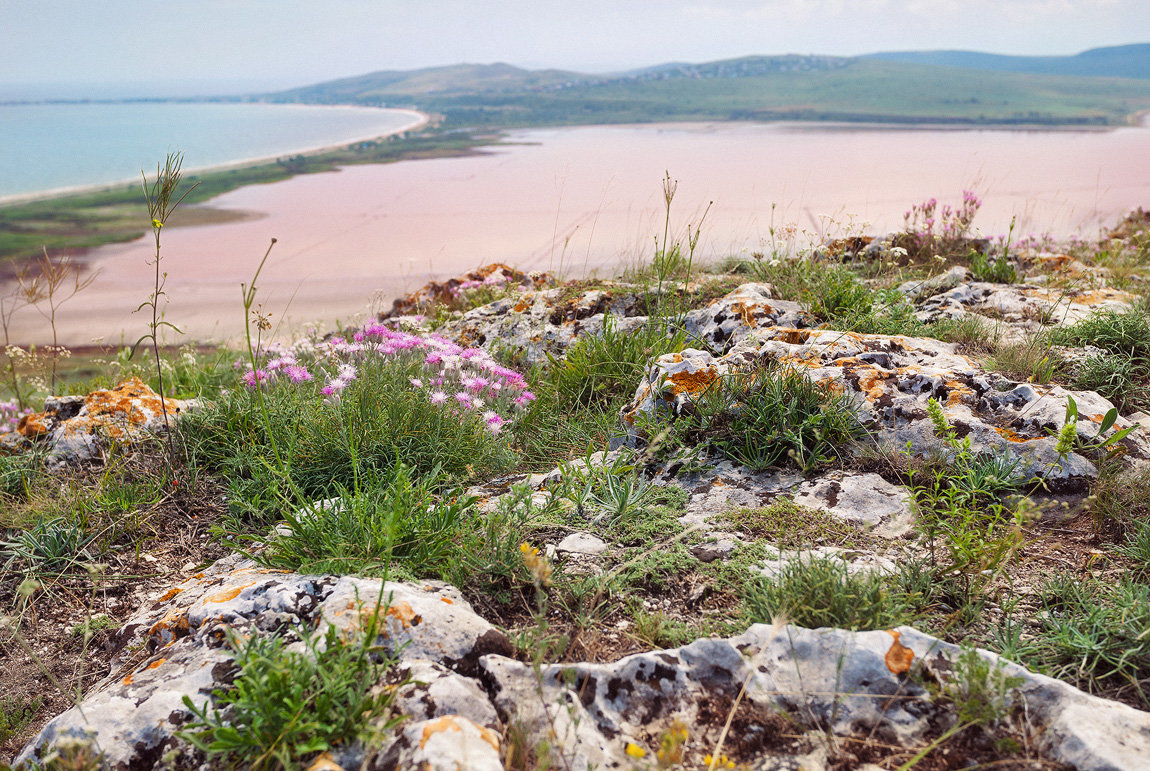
left=18, top=557, right=1150, bottom=770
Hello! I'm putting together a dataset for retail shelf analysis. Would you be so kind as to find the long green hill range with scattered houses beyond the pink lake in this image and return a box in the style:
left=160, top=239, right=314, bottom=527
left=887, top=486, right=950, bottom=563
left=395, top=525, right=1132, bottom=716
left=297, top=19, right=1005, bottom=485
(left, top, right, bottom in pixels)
left=261, top=52, right=1150, bottom=129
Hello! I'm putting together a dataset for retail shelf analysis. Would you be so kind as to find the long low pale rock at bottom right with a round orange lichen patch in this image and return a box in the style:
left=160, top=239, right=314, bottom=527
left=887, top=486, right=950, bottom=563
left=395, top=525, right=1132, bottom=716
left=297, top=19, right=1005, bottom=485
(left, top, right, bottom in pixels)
left=482, top=625, right=1150, bottom=770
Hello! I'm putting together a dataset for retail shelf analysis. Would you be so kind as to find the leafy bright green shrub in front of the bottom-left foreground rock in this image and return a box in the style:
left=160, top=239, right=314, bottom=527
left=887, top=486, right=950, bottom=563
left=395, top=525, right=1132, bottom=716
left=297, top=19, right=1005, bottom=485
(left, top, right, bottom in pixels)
left=179, top=624, right=399, bottom=769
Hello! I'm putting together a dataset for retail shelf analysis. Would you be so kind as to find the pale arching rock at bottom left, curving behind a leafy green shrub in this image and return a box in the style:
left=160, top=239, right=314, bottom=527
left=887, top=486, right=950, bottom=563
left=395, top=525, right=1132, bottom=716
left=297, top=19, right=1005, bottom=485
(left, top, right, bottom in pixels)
left=17, top=558, right=511, bottom=769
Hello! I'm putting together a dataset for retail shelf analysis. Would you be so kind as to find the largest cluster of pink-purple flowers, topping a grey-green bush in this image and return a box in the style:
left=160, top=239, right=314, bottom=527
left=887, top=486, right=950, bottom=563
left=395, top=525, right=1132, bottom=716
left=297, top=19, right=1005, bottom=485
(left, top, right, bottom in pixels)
left=240, top=322, right=535, bottom=434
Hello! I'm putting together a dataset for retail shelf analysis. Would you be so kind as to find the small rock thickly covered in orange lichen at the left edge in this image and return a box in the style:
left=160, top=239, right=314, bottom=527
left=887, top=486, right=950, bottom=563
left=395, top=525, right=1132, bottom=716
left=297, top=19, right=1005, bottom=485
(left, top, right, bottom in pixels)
left=0, top=377, right=197, bottom=465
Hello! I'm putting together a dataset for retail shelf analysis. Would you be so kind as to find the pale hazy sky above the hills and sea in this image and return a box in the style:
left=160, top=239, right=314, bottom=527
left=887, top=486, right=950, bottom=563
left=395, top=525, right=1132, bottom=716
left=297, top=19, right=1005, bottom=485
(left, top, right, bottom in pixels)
left=0, top=0, right=1150, bottom=98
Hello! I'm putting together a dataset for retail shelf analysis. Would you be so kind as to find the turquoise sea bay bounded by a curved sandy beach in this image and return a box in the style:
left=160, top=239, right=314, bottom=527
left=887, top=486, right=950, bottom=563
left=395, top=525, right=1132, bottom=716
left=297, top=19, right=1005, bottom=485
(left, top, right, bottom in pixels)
left=0, top=102, right=413, bottom=198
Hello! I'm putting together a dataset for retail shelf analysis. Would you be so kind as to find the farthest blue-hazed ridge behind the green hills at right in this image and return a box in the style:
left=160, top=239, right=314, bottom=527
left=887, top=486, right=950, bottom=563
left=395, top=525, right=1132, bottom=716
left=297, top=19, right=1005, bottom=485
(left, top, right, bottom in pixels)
left=861, top=43, right=1150, bottom=79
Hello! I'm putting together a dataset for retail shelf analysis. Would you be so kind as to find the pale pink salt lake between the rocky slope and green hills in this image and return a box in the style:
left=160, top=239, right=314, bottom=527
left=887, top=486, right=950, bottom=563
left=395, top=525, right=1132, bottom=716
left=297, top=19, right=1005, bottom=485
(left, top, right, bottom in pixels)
left=8, top=124, right=1150, bottom=345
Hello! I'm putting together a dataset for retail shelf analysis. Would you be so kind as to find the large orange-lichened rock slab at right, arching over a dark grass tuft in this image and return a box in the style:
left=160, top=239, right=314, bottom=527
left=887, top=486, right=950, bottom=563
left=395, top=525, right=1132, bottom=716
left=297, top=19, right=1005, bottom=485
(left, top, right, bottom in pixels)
left=623, top=327, right=1150, bottom=489
